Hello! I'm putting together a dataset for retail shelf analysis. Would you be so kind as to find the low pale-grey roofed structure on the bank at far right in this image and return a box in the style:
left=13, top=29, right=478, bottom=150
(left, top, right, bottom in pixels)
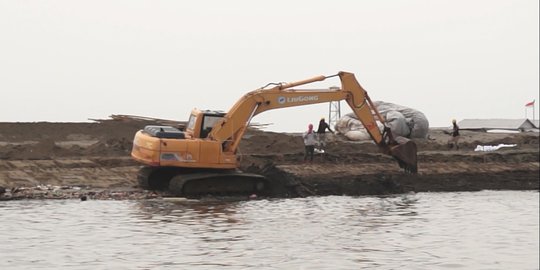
left=458, top=118, right=538, bottom=132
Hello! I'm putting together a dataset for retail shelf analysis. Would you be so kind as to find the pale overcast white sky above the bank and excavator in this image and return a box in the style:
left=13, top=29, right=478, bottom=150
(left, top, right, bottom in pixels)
left=0, top=0, right=540, bottom=132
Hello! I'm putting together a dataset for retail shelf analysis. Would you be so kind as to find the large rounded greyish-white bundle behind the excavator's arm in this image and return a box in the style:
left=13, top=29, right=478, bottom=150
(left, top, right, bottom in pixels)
left=334, top=101, right=429, bottom=141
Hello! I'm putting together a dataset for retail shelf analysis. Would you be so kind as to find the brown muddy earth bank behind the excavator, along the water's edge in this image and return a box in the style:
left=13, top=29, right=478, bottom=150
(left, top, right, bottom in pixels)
left=0, top=119, right=539, bottom=200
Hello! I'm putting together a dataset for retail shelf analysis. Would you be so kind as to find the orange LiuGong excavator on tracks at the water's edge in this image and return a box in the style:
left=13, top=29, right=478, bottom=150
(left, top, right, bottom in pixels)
left=131, top=71, right=417, bottom=197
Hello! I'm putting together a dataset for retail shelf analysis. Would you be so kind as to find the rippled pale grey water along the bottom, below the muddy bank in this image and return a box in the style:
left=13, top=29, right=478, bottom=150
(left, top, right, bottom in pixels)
left=0, top=191, right=539, bottom=269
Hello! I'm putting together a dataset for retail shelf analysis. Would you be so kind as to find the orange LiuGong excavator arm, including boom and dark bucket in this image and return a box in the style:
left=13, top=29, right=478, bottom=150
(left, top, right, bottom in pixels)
left=208, top=72, right=417, bottom=173
